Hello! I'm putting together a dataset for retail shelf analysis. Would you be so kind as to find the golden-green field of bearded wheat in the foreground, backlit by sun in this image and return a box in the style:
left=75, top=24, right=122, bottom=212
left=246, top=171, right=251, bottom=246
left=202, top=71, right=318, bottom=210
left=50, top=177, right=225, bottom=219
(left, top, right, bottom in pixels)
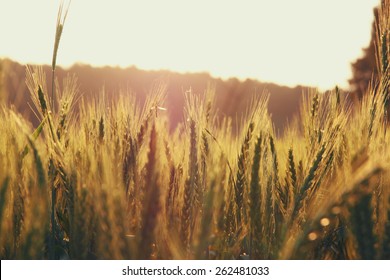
left=0, top=0, right=390, bottom=259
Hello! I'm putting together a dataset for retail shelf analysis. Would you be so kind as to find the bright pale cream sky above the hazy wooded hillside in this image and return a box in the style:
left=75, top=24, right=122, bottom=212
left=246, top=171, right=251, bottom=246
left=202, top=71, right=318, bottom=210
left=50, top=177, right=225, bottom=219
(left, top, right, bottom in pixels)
left=0, top=0, right=380, bottom=89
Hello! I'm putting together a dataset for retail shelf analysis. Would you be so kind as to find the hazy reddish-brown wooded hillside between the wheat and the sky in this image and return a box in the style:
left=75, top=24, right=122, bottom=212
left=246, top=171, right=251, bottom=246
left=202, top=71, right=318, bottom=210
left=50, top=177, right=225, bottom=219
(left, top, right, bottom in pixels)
left=0, top=60, right=307, bottom=131
